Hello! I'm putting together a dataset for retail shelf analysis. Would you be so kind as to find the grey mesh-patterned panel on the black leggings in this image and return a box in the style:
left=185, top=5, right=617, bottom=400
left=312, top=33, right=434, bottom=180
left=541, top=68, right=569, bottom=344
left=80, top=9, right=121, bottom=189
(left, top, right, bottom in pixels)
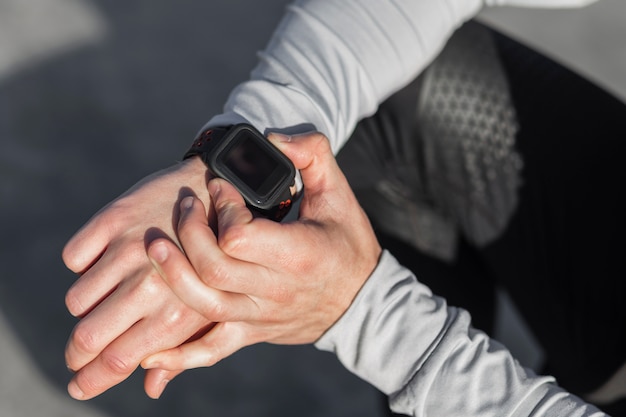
left=418, top=23, right=523, bottom=250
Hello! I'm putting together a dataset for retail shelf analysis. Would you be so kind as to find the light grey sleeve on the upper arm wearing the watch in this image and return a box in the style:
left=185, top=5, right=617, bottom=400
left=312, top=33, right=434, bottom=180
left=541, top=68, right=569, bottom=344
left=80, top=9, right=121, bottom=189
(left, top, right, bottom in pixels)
left=205, top=0, right=589, bottom=153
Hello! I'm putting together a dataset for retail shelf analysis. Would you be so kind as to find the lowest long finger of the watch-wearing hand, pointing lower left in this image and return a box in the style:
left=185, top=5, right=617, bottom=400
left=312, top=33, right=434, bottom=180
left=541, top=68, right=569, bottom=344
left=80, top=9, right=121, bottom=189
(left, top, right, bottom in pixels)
left=68, top=303, right=209, bottom=400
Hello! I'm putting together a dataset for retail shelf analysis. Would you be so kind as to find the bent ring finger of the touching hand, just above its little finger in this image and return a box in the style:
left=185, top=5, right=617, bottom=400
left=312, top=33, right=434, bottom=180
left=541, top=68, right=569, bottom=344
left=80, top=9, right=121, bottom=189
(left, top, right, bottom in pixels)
left=148, top=239, right=258, bottom=322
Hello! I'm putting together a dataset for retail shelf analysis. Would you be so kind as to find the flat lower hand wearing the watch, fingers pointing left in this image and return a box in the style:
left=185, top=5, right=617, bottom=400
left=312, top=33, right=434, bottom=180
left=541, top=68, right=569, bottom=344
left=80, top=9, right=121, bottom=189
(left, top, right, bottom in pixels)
left=63, top=154, right=211, bottom=400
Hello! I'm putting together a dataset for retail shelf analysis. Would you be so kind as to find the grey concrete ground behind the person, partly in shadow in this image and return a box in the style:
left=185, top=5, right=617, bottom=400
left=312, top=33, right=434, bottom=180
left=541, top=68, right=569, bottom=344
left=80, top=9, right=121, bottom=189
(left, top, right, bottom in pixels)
left=0, top=0, right=626, bottom=417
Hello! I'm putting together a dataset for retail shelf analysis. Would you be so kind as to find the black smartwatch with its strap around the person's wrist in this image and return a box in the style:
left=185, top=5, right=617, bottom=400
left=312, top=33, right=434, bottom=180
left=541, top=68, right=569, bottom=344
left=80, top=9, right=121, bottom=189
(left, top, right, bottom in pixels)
left=184, top=124, right=302, bottom=221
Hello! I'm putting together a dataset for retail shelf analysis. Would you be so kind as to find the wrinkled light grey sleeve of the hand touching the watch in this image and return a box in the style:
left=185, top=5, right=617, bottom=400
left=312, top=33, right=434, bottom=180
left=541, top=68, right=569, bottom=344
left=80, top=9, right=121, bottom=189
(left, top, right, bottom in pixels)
left=316, top=251, right=604, bottom=417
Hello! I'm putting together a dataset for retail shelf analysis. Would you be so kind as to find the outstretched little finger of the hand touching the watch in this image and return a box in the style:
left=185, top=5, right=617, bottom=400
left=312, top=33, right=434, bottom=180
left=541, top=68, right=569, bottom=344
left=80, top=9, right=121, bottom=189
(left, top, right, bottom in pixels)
left=141, top=323, right=252, bottom=370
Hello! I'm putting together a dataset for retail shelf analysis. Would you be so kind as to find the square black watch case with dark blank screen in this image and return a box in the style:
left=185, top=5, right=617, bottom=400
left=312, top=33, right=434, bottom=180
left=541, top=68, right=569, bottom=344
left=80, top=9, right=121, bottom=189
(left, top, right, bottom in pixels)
left=216, top=130, right=294, bottom=203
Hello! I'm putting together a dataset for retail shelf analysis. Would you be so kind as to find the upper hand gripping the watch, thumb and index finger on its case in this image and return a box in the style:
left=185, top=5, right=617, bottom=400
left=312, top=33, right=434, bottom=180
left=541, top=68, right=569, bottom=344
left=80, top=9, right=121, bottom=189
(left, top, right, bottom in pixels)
left=142, top=133, right=382, bottom=396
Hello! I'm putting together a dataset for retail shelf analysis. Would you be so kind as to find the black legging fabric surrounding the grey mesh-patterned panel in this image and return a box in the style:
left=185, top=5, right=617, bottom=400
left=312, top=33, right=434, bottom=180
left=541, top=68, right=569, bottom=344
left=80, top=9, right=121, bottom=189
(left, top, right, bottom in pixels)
left=338, top=23, right=626, bottom=412
